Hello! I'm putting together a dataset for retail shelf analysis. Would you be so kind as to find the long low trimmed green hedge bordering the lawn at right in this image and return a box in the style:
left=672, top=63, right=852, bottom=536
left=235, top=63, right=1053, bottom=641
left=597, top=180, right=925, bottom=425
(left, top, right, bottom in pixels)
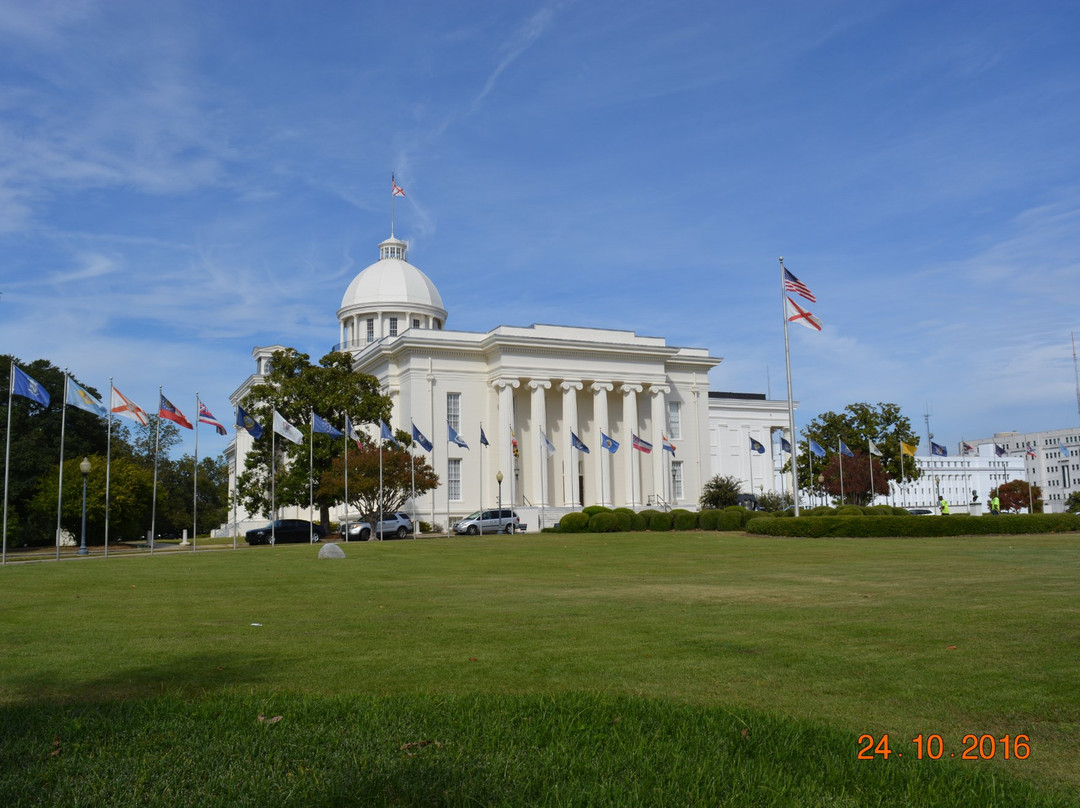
left=746, top=513, right=1080, bottom=539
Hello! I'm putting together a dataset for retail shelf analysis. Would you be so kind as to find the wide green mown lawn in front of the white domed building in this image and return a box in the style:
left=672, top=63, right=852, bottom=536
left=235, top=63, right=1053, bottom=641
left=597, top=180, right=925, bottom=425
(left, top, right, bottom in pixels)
left=0, top=533, right=1080, bottom=806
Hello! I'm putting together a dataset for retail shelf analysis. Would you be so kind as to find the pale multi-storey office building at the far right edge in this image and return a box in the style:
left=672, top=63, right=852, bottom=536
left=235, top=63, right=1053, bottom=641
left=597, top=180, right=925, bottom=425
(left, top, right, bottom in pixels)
left=968, top=427, right=1080, bottom=513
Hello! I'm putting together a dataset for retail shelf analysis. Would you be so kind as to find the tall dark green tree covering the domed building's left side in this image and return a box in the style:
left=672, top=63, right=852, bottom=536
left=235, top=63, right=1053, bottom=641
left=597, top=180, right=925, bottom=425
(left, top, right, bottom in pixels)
left=238, top=348, right=391, bottom=525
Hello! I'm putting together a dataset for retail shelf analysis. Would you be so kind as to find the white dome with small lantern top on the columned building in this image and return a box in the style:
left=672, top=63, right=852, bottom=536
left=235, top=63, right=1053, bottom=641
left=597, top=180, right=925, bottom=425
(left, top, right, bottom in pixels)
left=338, top=235, right=446, bottom=348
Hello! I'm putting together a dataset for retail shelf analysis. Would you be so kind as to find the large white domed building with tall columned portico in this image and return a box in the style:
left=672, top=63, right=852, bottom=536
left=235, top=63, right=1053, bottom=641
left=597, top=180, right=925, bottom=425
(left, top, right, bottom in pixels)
left=227, top=230, right=787, bottom=529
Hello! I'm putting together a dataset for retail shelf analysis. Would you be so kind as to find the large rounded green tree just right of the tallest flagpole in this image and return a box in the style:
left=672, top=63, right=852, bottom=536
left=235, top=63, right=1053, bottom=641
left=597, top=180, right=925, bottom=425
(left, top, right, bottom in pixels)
left=785, top=402, right=922, bottom=501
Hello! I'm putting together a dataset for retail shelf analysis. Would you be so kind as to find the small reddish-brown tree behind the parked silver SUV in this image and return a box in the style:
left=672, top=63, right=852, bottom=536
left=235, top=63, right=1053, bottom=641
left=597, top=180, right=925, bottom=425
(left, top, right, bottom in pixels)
left=319, top=443, right=438, bottom=517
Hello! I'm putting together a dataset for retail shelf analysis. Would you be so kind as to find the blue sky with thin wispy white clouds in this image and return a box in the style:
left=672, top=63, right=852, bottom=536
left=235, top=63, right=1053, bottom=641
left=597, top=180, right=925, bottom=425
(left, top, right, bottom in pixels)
left=0, top=0, right=1080, bottom=454
